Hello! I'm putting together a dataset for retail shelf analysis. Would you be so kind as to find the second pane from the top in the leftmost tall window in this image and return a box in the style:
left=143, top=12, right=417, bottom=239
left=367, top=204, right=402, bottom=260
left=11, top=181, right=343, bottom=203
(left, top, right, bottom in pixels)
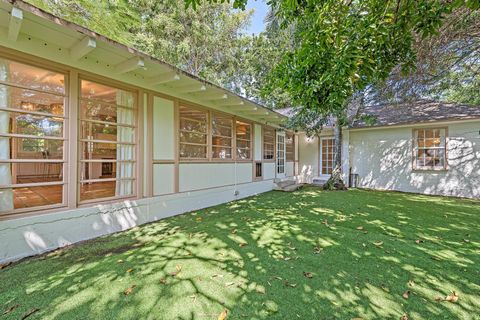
left=0, top=84, right=64, bottom=115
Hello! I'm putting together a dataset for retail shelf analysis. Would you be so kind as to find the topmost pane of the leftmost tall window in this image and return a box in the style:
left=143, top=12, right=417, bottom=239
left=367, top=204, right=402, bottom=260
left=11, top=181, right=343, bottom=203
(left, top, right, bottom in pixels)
left=0, top=58, right=65, bottom=94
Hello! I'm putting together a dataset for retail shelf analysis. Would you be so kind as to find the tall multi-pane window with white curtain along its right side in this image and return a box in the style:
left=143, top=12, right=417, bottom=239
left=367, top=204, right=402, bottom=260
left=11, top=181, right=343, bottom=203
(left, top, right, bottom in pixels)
left=79, top=80, right=136, bottom=201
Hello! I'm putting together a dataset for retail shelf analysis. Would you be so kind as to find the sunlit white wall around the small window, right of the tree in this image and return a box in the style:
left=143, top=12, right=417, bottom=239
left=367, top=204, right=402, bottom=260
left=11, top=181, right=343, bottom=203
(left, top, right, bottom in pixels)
left=350, top=121, right=480, bottom=198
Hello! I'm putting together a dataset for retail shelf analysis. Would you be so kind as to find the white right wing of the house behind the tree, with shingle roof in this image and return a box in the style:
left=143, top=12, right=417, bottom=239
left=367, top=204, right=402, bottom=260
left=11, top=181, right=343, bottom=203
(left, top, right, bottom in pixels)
left=298, top=102, right=480, bottom=198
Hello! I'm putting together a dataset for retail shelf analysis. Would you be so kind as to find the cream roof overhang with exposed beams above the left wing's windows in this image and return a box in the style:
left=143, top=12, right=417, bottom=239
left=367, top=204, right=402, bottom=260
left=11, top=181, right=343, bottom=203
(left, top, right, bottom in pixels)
left=0, top=0, right=286, bottom=126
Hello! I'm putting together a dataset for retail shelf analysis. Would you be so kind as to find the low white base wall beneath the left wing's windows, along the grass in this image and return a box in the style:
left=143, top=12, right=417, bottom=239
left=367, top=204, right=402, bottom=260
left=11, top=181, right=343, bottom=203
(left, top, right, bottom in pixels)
left=0, top=180, right=273, bottom=264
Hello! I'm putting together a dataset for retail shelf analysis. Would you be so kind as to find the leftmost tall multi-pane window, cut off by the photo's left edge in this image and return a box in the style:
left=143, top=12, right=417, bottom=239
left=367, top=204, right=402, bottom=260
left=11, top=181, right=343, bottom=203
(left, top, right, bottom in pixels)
left=0, top=58, right=67, bottom=213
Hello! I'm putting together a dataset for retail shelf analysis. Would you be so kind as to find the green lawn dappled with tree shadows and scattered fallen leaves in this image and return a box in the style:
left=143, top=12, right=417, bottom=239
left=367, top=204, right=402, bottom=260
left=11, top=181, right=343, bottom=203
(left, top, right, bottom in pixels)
left=0, top=188, right=480, bottom=320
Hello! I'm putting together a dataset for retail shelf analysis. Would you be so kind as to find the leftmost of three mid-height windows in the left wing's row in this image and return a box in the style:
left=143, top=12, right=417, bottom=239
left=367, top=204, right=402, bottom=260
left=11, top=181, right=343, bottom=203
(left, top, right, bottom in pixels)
left=179, top=106, right=208, bottom=159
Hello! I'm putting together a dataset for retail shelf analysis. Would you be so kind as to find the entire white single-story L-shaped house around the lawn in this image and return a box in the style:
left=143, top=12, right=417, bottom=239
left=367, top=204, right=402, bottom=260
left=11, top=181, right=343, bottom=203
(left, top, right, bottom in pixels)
left=0, top=0, right=480, bottom=263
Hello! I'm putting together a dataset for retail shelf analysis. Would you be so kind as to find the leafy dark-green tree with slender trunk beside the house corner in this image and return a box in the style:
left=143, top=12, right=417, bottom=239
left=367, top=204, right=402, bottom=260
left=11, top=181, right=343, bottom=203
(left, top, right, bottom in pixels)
left=185, top=0, right=480, bottom=189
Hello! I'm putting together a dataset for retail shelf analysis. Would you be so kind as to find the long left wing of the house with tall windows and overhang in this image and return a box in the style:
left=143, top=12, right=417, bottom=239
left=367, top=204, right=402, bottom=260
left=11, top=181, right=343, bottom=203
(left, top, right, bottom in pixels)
left=0, top=1, right=298, bottom=263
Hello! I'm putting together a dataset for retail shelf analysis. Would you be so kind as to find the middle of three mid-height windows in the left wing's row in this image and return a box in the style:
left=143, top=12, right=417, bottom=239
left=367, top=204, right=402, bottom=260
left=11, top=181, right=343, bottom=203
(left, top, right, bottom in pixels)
left=212, top=114, right=233, bottom=159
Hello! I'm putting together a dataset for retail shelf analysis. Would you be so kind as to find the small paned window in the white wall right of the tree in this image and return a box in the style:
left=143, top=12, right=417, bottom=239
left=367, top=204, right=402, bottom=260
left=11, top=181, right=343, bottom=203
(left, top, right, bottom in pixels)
left=413, top=128, right=447, bottom=170
